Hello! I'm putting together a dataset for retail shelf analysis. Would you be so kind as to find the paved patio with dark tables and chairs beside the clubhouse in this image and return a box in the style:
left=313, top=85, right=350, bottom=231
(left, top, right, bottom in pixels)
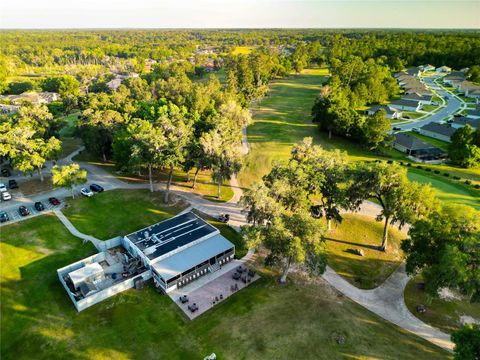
left=168, top=260, right=260, bottom=320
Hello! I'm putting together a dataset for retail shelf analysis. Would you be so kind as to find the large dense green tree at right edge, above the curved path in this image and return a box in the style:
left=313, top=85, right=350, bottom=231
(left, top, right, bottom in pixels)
left=402, top=205, right=480, bottom=301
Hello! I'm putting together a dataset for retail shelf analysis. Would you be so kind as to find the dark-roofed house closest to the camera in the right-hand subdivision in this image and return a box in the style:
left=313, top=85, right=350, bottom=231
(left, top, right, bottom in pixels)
left=393, top=133, right=447, bottom=161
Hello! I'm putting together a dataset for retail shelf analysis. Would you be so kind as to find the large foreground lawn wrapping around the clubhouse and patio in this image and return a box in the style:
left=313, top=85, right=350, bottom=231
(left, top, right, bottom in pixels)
left=0, top=215, right=449, bottom=360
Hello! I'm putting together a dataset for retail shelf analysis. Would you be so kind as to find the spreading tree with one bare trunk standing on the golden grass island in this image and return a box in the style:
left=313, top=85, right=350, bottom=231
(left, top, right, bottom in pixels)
left=347, top=162, right=438, bottom=251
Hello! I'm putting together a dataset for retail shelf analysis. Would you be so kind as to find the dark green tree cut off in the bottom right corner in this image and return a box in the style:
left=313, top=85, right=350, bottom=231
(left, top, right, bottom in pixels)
left=452, top=324, right=480, bottom=360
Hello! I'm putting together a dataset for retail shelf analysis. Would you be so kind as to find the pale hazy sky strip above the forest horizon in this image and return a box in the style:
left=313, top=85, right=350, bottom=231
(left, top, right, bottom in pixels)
left=0, top=0, right=480, bottom=29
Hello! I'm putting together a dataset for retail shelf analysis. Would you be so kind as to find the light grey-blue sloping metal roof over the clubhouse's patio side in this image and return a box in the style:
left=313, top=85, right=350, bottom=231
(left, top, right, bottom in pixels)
left=152, top=234, right=235, bottom=281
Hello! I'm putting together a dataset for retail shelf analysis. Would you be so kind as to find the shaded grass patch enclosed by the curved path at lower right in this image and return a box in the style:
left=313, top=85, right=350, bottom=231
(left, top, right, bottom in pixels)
left=404, top=276, right=480, bottom=333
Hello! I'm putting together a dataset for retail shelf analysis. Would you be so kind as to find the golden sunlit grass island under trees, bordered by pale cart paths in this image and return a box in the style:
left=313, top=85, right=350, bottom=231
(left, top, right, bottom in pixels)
left=325, top=214, right=407, bottom=289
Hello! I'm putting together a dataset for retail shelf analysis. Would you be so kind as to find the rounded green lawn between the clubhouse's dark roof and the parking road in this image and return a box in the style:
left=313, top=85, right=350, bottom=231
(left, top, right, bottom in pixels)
left=63, top=190, right=187, bottom=240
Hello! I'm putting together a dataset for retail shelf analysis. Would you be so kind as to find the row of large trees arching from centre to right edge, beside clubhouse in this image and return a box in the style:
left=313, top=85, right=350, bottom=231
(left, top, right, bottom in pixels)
left=241, top=138, right=480, bottom=301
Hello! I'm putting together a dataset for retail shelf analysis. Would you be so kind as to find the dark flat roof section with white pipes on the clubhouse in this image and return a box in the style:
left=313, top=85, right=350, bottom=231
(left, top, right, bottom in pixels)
left=126, top=212, right=219, bottom=260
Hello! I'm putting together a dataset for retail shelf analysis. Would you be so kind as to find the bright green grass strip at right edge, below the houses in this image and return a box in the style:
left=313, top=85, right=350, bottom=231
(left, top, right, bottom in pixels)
left=408, top=168, right=480, bottom=210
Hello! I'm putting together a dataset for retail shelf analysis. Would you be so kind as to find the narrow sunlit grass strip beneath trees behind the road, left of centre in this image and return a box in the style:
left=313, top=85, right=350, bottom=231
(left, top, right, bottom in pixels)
left=73, top=151, right=233, bottom=202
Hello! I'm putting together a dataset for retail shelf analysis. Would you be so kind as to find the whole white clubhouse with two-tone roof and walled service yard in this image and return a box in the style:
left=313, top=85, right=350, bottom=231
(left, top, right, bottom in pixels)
left=57, top=212, right=235, bottom=311
